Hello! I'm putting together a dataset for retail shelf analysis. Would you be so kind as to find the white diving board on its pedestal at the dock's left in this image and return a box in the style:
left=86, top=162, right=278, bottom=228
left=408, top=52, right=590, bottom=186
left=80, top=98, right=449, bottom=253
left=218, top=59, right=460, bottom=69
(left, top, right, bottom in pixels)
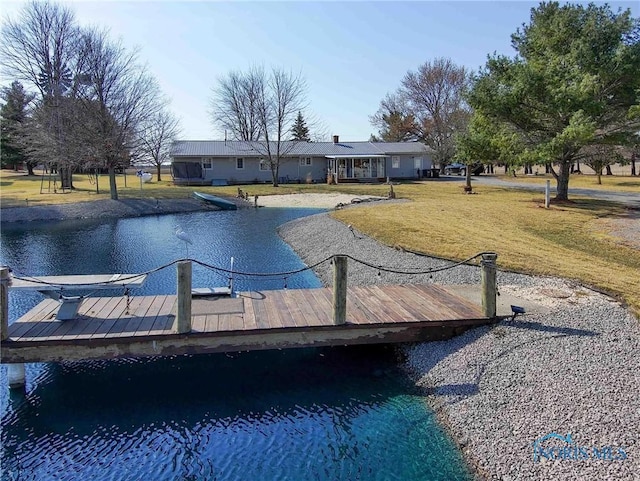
left=9, top=274, right=147, bottom=321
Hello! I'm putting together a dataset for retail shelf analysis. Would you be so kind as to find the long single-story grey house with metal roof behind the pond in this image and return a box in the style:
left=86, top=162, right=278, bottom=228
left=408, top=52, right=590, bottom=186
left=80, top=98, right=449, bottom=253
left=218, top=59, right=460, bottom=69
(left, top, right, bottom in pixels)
left=170, top=136, right=433, bottom=185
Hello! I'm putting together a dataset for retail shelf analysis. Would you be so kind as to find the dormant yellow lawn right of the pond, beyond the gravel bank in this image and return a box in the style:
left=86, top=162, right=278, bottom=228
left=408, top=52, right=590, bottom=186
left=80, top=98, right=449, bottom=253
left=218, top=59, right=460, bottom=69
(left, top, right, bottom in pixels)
left=334, top=182, right=640, bottom=314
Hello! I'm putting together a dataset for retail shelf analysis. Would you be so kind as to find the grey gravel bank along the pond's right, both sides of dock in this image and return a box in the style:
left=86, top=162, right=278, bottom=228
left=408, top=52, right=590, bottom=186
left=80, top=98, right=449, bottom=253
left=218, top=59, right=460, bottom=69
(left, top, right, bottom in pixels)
left=280, top=214, right=640, bottom=480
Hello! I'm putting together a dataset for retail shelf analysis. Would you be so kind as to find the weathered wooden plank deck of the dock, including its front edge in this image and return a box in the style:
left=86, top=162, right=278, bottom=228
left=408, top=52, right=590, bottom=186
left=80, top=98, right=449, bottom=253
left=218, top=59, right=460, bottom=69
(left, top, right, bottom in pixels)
left=0, top=285, right=491, bottom=363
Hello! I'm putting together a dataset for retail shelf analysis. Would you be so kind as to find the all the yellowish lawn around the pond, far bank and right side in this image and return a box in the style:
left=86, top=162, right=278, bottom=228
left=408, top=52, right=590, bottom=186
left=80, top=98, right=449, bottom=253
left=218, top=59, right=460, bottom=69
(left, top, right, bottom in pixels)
left=0, top=167, right=640, bottom=315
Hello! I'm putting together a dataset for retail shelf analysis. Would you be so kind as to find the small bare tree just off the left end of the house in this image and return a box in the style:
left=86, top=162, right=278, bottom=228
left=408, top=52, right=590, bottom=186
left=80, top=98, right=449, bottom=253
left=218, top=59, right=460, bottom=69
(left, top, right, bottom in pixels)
left=138, top=107, right=180, bottom=182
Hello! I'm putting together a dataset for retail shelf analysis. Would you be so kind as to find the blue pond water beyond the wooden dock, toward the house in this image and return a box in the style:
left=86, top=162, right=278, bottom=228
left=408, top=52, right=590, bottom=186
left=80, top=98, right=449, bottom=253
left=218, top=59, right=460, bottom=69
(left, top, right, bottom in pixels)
left=0, top=209, right=321, bottom=319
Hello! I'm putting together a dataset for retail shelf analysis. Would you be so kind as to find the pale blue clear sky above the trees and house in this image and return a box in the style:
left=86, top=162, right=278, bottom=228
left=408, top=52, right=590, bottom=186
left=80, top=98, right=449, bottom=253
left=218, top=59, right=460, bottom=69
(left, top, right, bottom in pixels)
left=0, top=1, right=640, bottom=141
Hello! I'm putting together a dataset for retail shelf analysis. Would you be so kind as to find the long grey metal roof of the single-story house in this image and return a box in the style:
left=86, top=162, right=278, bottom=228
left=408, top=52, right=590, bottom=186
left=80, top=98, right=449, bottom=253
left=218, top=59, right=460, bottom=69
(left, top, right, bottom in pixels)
left=171, top=140, right=430, bottom=158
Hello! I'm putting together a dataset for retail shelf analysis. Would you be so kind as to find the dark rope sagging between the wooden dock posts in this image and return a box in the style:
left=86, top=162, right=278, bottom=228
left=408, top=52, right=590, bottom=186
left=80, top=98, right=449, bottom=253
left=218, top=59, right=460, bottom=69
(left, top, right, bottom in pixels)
left=6, top=252, right=495, bottom=287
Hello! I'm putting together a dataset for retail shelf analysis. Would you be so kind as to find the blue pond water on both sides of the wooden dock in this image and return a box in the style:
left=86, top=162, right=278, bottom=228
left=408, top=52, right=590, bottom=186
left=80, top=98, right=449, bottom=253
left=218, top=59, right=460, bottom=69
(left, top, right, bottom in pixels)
left=0, top=209, right=470, bottom=481
